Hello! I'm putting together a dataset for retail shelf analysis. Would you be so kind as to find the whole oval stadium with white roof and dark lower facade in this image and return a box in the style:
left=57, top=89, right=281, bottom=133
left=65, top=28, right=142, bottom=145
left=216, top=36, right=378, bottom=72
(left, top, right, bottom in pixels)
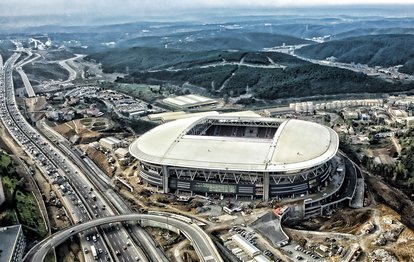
left=129, top=114, right=339, bottom=200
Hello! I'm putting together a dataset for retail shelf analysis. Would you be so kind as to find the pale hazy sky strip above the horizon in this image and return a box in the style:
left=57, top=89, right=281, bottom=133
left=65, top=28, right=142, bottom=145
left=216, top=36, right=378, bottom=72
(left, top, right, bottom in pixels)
left=0, top=0, right=414, bottom=16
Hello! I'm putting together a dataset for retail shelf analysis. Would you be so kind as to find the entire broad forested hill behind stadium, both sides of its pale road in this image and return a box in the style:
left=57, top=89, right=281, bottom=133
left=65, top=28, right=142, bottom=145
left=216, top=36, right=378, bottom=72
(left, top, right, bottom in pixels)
left=98, top=48, right=414, bottom=99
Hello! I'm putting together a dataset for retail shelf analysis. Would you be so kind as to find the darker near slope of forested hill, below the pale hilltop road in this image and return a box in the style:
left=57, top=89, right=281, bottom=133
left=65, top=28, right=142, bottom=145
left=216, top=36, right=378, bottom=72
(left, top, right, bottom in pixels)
left=119, top=61, right=414, bottom=99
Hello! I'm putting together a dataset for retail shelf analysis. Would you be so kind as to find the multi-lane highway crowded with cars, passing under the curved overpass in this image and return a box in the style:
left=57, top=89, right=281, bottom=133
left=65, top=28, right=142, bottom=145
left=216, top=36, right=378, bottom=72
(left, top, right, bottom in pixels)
left=0, top=53, right=146, bottom=262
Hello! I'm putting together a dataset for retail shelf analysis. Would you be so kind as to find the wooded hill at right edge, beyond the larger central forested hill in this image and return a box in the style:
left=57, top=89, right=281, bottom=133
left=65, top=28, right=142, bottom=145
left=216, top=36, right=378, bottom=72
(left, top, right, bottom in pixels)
left=295, top=34, right=414, bottom=74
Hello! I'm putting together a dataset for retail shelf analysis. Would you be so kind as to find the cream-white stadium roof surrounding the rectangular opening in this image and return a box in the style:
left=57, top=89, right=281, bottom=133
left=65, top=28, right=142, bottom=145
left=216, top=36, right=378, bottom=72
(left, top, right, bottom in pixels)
left=129, top=115, right=339, bottom=172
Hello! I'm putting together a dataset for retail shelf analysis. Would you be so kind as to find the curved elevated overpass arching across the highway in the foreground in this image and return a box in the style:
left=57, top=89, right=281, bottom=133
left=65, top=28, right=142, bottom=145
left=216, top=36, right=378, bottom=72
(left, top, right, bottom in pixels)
left=24, top=214, right=223, bottom=262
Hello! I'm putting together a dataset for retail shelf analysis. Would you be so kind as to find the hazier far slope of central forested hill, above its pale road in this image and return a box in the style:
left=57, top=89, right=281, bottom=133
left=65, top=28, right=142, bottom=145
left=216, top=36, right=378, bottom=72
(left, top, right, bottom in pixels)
left=85, top=47, right=304, bottom=73
